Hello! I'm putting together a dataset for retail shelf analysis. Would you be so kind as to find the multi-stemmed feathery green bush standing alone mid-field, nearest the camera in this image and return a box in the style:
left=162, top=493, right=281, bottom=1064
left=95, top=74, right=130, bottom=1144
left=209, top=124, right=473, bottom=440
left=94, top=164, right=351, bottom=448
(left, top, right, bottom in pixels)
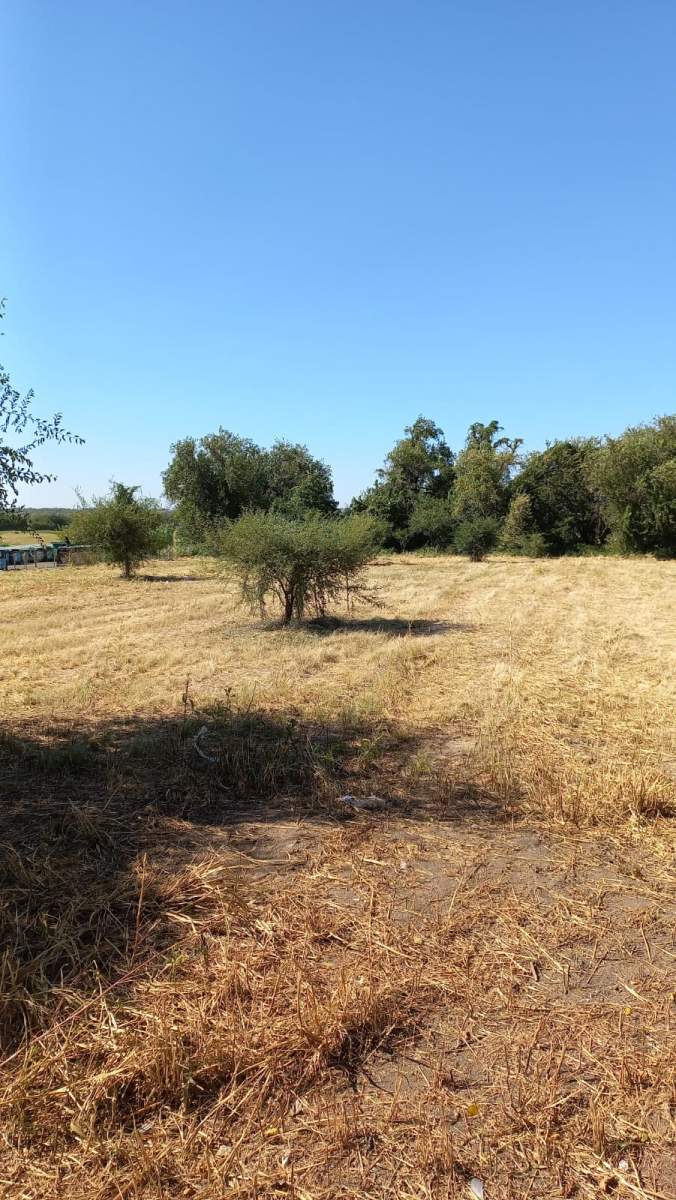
left=219, top=512, right=382, bottom=625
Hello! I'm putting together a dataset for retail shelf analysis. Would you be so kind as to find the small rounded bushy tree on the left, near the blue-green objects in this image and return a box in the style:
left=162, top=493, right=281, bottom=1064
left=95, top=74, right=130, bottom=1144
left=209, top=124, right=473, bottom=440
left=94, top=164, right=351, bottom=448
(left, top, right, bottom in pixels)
left=70, top=484, right=171, bottom=580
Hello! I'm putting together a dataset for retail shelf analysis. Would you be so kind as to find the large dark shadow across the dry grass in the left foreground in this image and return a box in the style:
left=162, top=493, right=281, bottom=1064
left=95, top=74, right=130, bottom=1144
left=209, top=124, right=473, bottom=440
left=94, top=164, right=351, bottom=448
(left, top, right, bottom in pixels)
left=0, top=703, right=497, bottom=1049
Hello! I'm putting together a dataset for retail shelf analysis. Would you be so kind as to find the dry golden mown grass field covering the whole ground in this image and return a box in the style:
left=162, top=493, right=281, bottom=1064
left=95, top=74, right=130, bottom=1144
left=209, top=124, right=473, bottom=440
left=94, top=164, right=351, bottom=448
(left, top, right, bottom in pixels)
left=0, top=557, right=676, bottom=1200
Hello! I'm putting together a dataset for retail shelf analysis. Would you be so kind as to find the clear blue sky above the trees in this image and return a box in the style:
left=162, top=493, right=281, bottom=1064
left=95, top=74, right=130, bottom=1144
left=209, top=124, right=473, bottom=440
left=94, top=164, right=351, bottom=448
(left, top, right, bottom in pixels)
left=5, top=0, right=676, bottom=504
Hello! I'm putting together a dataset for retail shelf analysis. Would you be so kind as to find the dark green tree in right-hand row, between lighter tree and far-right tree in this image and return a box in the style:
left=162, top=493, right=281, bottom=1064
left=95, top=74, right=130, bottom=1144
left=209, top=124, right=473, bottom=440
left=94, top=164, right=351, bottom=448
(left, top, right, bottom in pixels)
left=512, top=438, right=608, bottom=554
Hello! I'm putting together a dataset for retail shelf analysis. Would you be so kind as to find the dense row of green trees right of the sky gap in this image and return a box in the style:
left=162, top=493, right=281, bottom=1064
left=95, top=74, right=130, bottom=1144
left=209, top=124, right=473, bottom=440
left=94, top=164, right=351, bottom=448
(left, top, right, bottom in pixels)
left=352, top=416, right=676, bottom=558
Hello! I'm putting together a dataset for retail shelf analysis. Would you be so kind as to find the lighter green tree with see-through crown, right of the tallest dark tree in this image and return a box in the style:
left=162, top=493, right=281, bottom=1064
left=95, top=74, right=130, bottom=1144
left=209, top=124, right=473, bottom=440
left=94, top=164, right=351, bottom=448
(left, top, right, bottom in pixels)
left=450, top=421, right=521, bottom=528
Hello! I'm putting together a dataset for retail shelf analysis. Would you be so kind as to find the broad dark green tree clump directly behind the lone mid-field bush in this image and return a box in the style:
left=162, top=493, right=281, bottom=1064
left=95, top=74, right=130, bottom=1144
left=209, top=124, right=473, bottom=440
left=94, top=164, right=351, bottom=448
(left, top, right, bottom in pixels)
left=163, top=430, right=337, bottom=541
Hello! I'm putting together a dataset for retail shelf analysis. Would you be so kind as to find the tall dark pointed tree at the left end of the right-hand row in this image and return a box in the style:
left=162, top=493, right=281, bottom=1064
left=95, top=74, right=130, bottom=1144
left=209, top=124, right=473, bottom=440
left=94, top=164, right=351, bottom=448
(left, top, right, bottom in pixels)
left=351, top=416, right=454, bottom=550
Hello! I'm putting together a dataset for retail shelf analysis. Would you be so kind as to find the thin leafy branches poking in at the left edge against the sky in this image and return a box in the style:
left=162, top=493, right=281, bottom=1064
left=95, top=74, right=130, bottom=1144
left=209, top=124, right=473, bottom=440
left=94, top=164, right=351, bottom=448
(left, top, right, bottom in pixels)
left=0, top=300, right=83, bottom=512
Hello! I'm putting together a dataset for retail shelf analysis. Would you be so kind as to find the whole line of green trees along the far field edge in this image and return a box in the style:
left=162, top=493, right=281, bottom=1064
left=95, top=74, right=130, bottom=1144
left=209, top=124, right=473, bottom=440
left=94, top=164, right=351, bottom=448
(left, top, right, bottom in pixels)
left=163, top=415, right=676, bottom=558
